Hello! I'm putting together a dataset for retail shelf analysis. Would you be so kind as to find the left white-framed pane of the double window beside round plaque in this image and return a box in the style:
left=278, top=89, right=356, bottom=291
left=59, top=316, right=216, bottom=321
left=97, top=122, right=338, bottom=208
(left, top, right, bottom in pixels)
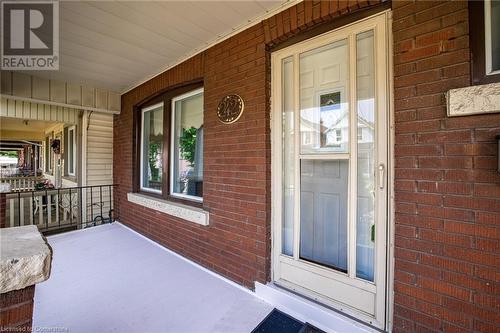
left=141, top=103, right=163, bottom=193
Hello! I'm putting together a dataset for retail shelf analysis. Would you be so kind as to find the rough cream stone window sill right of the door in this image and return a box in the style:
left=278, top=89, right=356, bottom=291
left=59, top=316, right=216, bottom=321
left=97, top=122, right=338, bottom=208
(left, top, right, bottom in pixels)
left=446, top=83, right=500, bottom=117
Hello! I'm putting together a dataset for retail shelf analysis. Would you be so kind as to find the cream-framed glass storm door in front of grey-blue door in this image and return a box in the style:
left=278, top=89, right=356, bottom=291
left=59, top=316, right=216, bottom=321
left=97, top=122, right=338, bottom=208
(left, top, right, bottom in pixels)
left=272, top=13, right=389, bottom=328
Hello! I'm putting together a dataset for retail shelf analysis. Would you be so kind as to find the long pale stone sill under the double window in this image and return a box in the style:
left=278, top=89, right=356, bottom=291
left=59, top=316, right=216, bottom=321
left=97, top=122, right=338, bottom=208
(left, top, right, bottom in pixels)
left=127, top=193, right=209, bottom=226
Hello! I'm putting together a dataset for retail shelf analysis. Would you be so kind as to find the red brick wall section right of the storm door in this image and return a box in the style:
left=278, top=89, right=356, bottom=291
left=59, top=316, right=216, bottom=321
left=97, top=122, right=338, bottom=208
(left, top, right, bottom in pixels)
left=393, top=1, right=500, bottom=332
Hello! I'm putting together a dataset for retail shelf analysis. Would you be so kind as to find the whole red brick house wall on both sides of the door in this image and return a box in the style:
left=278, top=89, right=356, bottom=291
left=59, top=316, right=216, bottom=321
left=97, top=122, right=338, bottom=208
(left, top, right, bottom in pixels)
left=114, top=1, right=500, bottom=332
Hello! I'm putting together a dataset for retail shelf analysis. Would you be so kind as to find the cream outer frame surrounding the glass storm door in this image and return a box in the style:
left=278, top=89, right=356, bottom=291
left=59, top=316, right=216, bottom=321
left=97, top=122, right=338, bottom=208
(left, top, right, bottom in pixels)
left=271, top=10, right=394, bottom=329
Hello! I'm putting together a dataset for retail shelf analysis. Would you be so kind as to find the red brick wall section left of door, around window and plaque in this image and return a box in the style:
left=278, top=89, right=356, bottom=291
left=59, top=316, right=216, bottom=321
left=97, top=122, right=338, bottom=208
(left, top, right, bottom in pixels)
left=113, top=0, right=379, bottom=288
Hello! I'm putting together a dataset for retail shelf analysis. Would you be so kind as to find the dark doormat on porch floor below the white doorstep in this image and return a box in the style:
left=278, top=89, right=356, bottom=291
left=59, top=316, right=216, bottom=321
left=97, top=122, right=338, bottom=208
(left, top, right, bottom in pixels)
left=252, top=309, right=325, bottom=333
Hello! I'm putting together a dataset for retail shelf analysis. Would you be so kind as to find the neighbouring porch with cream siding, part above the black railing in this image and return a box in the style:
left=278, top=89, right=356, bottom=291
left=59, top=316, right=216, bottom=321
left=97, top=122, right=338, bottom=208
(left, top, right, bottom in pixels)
left=0, top=72, right=116, bottom=187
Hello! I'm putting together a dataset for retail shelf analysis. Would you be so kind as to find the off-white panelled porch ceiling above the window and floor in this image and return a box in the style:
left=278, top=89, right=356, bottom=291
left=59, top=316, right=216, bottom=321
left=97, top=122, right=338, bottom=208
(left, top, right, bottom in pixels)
left=17, top=0, right=296, bottom=93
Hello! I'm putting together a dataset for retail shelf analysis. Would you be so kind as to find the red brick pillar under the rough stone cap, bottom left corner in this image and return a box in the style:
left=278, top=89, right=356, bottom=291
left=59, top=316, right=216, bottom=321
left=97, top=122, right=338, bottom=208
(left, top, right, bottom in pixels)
left=0, top=286, right=35, bottom=332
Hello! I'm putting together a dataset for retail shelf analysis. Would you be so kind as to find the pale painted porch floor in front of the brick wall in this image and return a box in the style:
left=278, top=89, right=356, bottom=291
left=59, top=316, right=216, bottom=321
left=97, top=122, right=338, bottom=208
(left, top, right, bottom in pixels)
left=33, top=223, right=273, bottom=333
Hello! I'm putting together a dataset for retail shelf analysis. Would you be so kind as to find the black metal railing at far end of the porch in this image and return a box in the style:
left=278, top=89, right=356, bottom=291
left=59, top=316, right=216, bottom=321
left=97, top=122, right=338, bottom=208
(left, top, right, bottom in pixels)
left=3, top=185, right=118, bottom=234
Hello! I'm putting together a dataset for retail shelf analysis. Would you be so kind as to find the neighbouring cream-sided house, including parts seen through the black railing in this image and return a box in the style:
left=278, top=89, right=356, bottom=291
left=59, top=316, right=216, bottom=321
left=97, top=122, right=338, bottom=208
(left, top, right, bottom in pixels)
left=0, top=72, right=120, bottom=228
